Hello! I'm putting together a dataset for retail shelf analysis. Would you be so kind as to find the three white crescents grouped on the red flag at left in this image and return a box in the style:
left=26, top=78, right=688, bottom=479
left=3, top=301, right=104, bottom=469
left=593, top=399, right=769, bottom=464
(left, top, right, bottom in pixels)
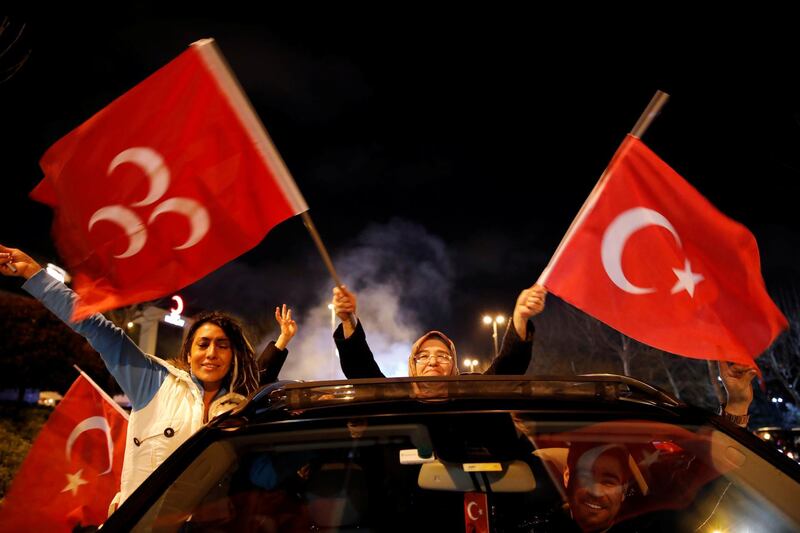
left=89, top=146, right=211, bottom=259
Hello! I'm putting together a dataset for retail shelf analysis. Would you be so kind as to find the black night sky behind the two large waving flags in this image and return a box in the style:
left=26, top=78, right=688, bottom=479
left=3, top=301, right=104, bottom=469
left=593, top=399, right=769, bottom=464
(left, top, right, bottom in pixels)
left=0, top=14, right=800, bottom=374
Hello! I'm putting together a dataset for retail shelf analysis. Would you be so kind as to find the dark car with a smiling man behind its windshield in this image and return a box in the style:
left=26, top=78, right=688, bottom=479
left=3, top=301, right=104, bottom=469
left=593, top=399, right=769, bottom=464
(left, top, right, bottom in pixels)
left=102, top=374, right=800, bottom=532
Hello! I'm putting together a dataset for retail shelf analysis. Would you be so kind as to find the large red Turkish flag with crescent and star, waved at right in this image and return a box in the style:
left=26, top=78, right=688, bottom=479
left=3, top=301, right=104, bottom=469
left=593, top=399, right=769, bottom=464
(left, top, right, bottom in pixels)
left=542, top=136, right=787, bottom=366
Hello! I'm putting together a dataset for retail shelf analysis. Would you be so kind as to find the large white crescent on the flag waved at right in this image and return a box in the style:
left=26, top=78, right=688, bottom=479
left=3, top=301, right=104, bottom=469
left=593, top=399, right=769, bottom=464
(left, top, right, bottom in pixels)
left=600, top=207, right=681, bottom=294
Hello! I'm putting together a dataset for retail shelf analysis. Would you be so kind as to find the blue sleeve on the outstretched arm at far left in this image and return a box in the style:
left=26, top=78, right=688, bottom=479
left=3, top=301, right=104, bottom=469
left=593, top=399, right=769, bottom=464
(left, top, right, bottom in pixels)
left=22, top=270, right=167, bottom=409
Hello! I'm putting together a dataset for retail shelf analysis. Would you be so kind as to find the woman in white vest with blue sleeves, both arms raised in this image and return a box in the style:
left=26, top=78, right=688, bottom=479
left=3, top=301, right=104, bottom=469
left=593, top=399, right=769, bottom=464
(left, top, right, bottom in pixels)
left=0, top=245, right=296, bottom=503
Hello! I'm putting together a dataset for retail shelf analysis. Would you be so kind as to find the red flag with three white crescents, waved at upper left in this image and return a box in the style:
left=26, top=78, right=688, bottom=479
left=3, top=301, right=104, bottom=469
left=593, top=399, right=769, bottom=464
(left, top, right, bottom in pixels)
left=31, top=39, right=308, bottom=320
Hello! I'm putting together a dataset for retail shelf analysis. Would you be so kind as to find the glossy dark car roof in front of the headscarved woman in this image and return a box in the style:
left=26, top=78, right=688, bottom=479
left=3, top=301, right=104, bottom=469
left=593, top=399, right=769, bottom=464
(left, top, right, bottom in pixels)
left=231, top=374, right=687, bottom=421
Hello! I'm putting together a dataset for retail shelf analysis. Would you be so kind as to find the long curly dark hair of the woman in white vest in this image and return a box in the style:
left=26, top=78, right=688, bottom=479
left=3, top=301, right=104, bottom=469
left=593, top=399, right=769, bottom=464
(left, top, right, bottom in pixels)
left=176, top=311, right=258, bottom=396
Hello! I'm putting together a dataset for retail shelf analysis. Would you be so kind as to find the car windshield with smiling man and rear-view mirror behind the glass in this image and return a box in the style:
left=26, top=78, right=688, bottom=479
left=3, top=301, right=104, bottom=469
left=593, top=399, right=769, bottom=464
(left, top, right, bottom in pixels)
left=123, top=378, right=800, bottom=532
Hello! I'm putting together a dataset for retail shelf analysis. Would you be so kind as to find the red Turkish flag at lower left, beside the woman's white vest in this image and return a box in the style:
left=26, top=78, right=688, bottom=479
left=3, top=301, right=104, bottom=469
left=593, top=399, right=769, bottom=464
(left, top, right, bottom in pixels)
left=0, top=375, right=128, bottom=533
